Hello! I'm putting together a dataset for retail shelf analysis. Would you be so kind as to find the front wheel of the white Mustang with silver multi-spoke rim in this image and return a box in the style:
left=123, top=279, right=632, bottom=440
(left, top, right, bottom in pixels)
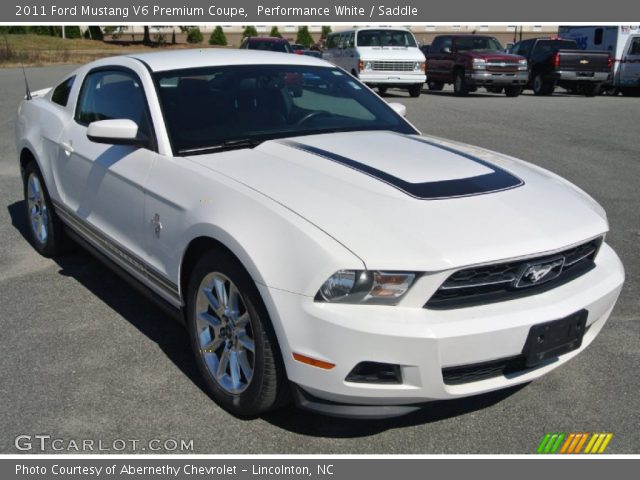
left=187, top=251, right=288, bottom=416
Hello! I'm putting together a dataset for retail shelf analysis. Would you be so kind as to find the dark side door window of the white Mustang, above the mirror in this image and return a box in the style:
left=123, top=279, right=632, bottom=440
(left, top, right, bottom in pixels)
left=76, top=70, right=148, bottom=132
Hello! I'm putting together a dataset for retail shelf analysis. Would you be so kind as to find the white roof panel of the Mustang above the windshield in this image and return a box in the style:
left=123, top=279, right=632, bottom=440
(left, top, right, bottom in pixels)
left=128, top=48, right=333, bottom=72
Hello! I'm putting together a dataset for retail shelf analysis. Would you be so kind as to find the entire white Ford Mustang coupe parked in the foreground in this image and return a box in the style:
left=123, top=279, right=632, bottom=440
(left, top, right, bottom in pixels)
left=16, top=50, right=624, bottom=418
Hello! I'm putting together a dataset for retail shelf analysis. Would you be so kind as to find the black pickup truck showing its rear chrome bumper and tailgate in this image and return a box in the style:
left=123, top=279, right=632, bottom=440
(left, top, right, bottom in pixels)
left=509, top=38, right=612, bottom=96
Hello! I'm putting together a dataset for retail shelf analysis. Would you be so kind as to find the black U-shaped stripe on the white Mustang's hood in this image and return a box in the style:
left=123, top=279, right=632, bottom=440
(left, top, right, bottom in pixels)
left=279, top=135, right=524, bottom=200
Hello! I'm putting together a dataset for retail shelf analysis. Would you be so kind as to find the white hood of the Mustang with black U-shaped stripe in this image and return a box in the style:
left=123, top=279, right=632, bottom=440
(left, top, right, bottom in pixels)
left=192, top=132, right=607, bottom=271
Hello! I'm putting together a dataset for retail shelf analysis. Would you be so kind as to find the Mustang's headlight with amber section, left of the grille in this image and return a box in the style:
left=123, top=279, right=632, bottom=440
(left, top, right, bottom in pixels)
left=315, top=270, right=416, bottom=305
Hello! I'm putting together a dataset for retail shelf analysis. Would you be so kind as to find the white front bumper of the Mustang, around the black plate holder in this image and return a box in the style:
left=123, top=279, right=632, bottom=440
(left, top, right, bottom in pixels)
left=259, top=244, right=624, bottom=417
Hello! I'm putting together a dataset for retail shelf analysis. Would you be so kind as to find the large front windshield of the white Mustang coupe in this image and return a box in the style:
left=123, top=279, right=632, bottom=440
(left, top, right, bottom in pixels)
left=154, top=65, right=417, bottom=155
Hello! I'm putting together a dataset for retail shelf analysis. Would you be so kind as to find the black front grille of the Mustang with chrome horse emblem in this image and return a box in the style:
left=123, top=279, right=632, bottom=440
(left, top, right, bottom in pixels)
left=425, top=238, right=602, bottom=309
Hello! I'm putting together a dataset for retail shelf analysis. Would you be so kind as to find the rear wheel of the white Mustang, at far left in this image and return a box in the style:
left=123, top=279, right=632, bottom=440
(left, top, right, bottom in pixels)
left=23, top=160, right=70, bottom=257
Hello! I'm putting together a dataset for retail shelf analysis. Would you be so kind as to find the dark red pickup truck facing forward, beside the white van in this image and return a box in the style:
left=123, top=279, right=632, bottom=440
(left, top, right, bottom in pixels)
left=423, top=35, right=529, bottom=97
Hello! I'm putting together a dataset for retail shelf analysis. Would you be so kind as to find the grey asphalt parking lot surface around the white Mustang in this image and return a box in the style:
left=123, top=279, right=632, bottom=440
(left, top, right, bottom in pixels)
left=0, top=66, right=640, bottom=454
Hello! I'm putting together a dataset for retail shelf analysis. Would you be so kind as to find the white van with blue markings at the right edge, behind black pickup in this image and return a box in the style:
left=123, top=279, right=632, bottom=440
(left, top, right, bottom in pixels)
left=558, top=25, right=640, bottom=95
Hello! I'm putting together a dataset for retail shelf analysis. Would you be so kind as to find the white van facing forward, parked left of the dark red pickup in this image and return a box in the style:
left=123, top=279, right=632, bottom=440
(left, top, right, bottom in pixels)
left=323, top=27, right=426, bottom=97
